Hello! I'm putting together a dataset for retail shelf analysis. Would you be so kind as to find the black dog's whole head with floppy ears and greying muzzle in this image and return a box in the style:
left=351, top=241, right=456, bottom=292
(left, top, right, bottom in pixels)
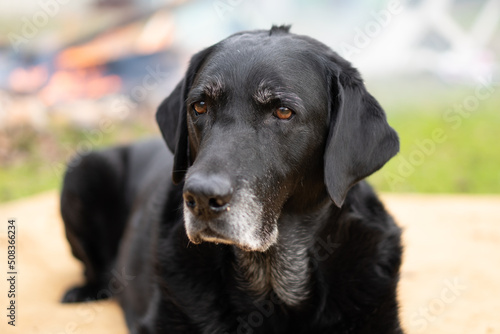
left=157, top=27, right=399, bottom=251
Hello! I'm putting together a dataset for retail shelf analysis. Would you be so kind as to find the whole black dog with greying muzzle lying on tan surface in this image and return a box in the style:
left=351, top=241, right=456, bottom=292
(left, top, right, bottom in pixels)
left=61, top=27, right=402, bottom=334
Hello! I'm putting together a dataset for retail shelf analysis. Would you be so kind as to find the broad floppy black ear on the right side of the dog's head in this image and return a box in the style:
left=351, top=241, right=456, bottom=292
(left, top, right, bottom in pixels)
left=324, top=68, right=399, bottom=207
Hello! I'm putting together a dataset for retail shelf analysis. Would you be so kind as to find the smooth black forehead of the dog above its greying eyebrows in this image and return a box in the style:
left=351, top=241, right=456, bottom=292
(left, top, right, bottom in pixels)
left=195, top=33, right=326, bottom=101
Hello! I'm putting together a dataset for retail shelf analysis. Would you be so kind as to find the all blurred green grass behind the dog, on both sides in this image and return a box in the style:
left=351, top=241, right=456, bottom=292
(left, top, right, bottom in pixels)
left=0, top=83, right=500, bottom=202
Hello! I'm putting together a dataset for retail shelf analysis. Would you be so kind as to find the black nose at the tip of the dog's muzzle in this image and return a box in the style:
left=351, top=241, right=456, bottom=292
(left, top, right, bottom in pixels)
left=184, top=173, right=233, bottom=219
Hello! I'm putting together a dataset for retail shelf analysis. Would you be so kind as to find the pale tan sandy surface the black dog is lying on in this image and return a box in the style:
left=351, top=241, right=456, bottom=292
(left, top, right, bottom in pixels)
left=0, top=192, right=500, bottom=334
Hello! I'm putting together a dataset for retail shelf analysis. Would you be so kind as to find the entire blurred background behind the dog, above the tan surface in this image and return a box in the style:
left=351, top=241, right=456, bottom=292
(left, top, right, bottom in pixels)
left=0, top=0, right=500, bottom=202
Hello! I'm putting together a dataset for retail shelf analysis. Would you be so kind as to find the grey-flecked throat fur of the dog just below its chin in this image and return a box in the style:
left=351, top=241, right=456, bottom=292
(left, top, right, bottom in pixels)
left=234, top=202, right=332, bottom=306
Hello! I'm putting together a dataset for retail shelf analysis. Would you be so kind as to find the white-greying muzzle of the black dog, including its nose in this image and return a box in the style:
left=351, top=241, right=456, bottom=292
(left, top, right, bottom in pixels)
left=183, top=172, right=278, bottom=251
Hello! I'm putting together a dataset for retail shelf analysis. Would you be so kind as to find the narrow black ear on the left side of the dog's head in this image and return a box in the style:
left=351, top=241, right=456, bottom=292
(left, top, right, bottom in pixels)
left=156, top=46, right=213, bottom=184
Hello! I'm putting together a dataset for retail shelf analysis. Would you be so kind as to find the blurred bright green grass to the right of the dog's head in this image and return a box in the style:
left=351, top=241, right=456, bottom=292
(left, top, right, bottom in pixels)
left=369, top=80, right=500, bottom=194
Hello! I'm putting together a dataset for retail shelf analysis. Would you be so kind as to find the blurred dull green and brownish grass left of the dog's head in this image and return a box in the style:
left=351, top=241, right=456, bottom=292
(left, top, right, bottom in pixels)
left=0, top=116, right=159, bottom=202
